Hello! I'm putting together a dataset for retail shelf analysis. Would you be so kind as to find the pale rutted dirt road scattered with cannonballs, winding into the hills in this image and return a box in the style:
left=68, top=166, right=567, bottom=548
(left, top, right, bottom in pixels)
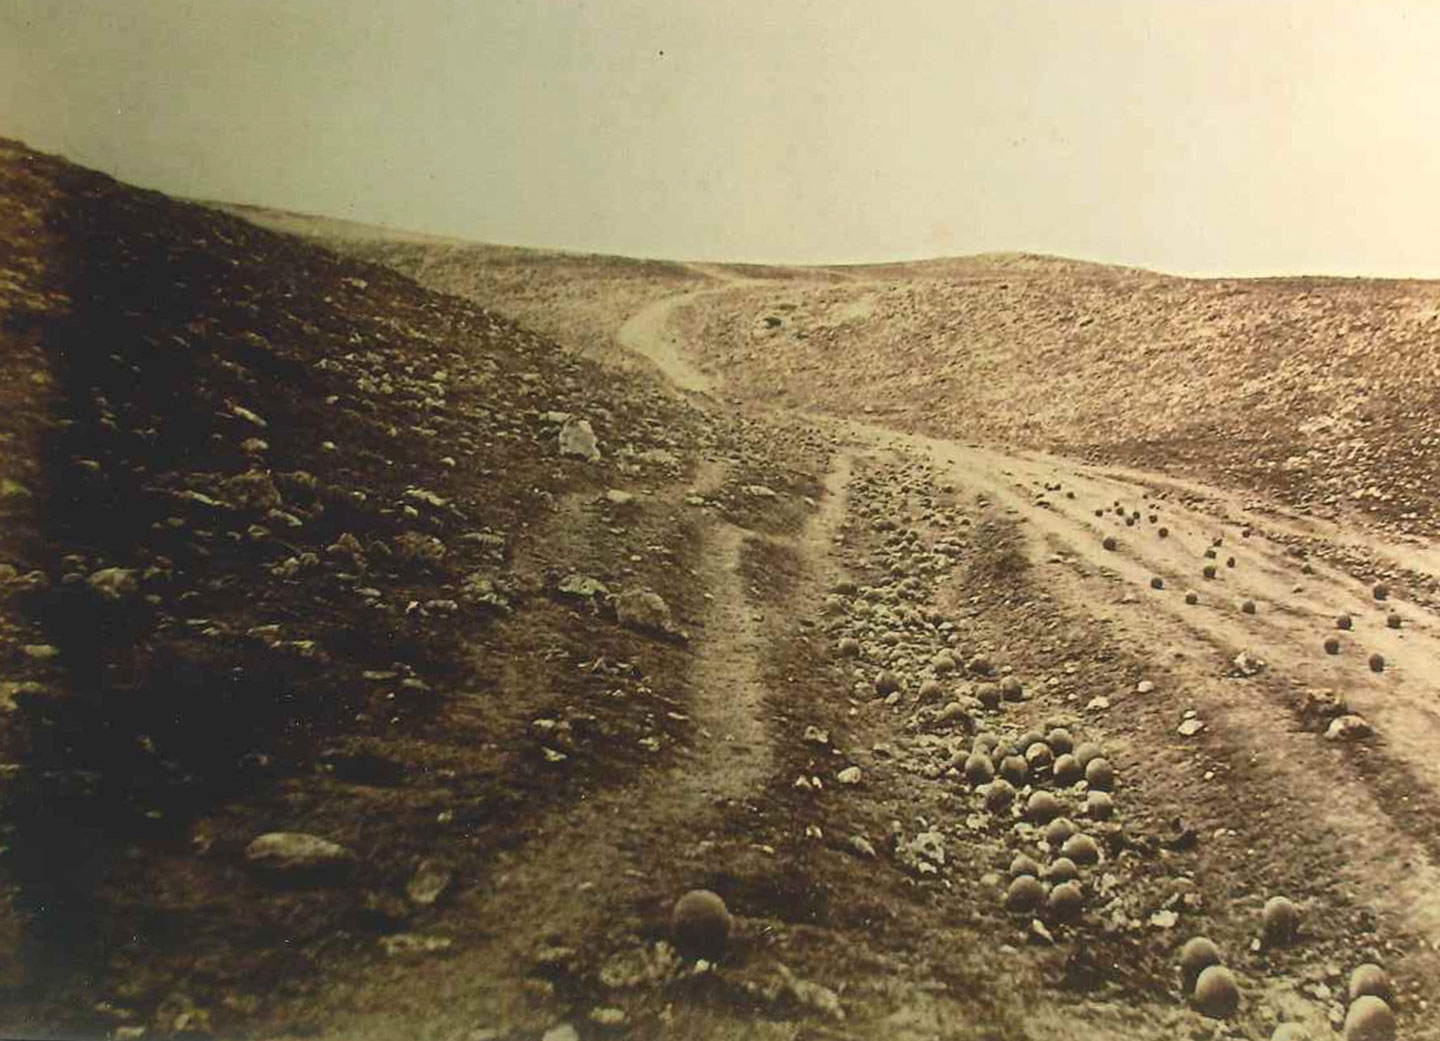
left=621, top=285, right=1440, bottom=1037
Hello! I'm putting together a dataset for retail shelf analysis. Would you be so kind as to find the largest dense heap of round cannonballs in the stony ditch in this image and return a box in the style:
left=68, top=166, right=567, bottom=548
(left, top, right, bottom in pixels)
left=963, top=724, right=1115, bottom=921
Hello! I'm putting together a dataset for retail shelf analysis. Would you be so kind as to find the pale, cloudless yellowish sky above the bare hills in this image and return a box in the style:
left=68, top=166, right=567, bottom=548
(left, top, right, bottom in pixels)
left=0, top=0, right=1440, bottom=276
